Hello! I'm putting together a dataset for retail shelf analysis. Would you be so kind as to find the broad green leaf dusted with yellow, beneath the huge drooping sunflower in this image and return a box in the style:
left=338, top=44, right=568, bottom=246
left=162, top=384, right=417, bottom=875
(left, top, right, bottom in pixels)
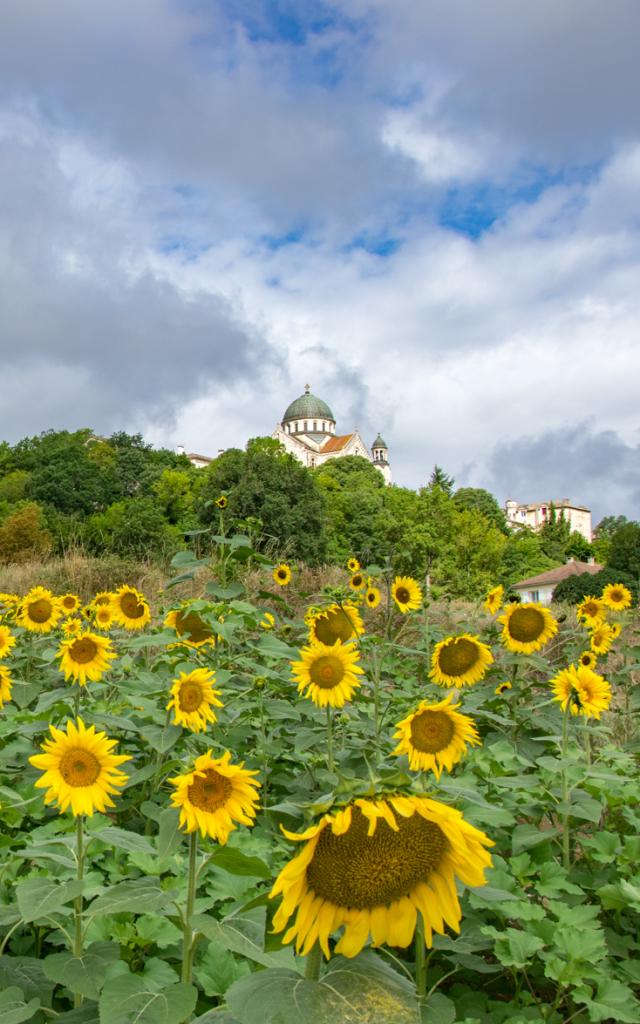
left=226, top=952, right=418, bottom=1024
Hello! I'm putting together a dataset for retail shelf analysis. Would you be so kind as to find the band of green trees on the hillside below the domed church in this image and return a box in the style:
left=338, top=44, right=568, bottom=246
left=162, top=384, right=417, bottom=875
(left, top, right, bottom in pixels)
left=0, top=429, right=640, bottom=599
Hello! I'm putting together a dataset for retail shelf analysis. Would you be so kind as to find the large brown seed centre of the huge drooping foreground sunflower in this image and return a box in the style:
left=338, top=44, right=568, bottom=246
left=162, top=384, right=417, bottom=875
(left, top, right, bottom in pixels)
left=306, top=809, right=449, bottom=910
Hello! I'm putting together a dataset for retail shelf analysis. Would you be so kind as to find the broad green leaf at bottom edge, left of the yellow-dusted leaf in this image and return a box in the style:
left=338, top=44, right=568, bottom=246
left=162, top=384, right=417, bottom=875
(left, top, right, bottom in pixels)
left=99, top=974, right=198, bottom=1024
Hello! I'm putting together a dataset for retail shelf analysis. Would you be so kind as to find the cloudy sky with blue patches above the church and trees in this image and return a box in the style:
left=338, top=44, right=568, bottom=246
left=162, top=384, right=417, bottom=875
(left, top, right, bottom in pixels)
left=0, top=0, right=640, bottom=522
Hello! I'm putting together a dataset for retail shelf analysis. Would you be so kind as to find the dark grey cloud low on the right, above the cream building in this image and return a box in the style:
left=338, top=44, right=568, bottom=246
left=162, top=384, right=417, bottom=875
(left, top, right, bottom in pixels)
left=485, top=423, right=640, bottom=525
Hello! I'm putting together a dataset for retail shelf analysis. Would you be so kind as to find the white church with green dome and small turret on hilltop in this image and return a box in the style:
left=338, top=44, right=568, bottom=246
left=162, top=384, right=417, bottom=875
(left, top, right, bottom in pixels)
left=271, top=384, right=391, bottom=484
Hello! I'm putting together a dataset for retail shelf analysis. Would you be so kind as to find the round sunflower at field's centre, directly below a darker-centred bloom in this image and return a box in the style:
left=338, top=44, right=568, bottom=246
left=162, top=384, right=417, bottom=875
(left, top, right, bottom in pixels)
left=291, top=640, right=362, bottom=708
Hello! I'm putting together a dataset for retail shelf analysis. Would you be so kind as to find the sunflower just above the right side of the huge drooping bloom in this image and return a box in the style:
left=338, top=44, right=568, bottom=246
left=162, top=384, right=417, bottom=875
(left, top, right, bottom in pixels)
left=393, top=693, right=480, bottom=778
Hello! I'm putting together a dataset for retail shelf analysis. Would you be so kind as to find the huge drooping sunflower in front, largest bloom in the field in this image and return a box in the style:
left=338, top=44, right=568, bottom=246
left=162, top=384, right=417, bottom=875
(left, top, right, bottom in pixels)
left=270, top=797, right=493, bottom=957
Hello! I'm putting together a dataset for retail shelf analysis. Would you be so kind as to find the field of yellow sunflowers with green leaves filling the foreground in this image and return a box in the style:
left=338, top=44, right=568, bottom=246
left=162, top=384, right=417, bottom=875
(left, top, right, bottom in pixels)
left=0, top=520, right=640, bottom=1024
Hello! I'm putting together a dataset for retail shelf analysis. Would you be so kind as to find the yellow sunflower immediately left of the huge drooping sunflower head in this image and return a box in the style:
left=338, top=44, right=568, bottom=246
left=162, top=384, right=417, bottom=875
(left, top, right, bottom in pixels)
left=169, top=751, right=260, bottom=844
